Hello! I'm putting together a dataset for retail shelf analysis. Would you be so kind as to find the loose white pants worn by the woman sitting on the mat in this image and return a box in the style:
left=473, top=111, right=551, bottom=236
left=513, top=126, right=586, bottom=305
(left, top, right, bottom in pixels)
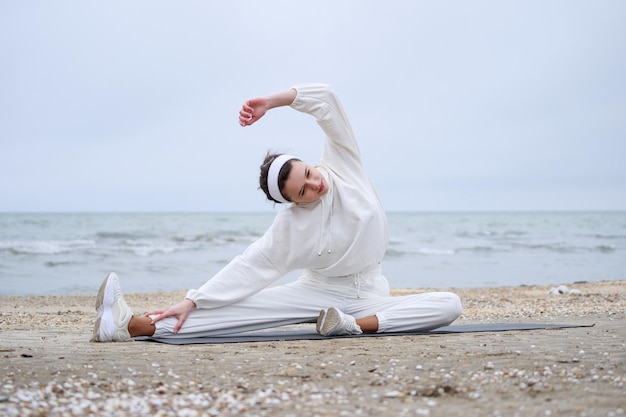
left=154, top=267, right=463, bottom=338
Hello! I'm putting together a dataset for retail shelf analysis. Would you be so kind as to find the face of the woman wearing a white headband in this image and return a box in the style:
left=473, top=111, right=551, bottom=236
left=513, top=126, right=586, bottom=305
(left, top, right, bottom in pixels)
left=282, top=161, right=328, bottom=204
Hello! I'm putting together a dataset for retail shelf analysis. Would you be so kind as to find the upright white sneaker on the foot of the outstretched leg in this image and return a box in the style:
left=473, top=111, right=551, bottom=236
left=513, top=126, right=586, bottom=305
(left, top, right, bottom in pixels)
left=91, top=272, right=133, bottom=342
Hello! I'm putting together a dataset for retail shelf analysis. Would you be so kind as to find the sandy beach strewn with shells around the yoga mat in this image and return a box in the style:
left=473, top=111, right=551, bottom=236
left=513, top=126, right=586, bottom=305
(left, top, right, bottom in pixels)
left=0, top=281, right=626, bottom=416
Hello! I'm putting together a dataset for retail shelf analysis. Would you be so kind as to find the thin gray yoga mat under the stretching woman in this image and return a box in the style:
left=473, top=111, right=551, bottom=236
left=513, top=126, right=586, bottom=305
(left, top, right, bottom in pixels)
left=135, top=323, right=594, bottom=345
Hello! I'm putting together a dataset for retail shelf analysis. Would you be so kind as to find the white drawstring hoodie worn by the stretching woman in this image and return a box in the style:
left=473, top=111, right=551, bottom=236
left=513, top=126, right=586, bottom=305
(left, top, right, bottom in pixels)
left=186, top=84, right=387, bottom=308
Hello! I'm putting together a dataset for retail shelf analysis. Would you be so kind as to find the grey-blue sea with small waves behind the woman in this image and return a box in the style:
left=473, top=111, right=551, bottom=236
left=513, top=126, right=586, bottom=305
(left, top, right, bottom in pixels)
left=0, top=212, right=626, bottom=295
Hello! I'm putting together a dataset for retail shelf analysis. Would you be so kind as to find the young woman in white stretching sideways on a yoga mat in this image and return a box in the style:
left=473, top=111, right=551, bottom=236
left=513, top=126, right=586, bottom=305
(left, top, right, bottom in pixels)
left=93, top=84, right=462, bottom=342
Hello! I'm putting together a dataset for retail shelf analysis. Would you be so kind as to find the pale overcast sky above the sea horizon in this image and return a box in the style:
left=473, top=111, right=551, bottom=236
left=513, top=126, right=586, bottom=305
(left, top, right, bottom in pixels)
left=0, top=0, right=626, bottom=212
